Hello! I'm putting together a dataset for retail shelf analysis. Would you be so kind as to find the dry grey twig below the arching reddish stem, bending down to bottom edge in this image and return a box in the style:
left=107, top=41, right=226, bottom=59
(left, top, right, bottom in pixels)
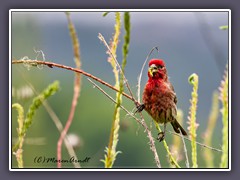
left=88, top=78, right=161, bottom=168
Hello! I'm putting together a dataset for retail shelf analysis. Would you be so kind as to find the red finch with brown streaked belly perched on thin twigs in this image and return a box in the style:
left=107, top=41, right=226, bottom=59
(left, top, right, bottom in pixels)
left=138, top=59, right=187, bottom=141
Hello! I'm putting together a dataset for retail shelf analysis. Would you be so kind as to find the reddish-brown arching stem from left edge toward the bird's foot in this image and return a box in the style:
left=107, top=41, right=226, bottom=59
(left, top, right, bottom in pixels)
left=12, top=60, right=134, bottom=104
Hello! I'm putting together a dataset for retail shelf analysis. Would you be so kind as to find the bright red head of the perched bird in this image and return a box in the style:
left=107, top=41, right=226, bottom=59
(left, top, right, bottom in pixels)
left=148, top=59, right=167, bottom=80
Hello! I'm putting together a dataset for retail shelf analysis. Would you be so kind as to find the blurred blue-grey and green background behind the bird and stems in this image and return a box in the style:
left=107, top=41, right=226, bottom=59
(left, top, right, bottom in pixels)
left=11, top=12, right=228, bottom=168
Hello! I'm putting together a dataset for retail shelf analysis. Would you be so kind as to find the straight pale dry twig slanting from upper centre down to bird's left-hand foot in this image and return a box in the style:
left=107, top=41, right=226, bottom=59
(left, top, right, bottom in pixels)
left=98, top=33, right=138, bottom=106
